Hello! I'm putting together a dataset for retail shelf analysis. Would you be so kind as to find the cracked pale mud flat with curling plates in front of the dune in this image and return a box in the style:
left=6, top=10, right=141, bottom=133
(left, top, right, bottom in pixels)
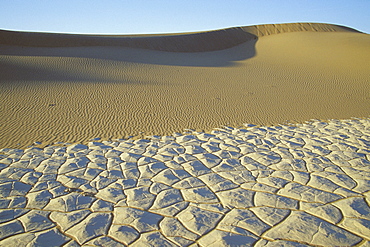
left=0, top=119, right=370, bottom=246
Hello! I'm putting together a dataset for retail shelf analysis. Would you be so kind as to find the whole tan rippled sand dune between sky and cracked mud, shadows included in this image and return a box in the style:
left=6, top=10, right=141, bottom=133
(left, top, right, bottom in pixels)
left=0, top=24, right=370, bottom=148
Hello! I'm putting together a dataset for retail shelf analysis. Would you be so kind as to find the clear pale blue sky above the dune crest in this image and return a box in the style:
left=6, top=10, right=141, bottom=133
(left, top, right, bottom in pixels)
left=0, top=0, right=370, bottom=34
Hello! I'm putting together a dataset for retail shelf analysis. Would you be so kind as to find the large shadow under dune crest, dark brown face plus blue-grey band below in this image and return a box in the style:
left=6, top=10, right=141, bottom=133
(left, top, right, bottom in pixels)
left=0, top=28, right=258, bottom=67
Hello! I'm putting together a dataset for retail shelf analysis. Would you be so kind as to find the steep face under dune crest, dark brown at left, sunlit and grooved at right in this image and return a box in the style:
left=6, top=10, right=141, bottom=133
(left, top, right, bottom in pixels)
left=0, top=23, right=359, bottom=52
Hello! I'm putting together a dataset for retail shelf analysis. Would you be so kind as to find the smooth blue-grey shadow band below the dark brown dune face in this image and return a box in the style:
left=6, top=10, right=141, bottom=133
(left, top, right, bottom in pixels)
left=0, top=38, right=257, bottom=67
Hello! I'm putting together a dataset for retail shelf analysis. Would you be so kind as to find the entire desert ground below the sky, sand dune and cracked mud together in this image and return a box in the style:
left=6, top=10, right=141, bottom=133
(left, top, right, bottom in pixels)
left=0, top=23, right=370, bottom=247
